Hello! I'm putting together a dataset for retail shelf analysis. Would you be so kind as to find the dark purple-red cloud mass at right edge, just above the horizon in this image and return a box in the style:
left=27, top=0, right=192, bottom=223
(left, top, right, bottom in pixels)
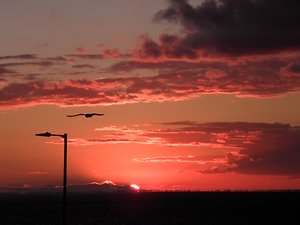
left=201, top=127, right=300, bottom=176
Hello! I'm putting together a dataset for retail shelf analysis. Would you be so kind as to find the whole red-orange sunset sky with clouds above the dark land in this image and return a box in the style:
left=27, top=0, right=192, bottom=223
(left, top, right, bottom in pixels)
left=0, top=0, right=300, bottom=190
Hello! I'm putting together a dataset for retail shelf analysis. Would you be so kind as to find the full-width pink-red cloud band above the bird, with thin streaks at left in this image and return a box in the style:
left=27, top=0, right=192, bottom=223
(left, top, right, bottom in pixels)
left=0, top=52, right=300, bottom=109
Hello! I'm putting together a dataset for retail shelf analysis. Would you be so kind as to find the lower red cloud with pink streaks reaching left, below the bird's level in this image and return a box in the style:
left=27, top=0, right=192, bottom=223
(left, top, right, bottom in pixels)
left=50, top=121, right=300, bottom=176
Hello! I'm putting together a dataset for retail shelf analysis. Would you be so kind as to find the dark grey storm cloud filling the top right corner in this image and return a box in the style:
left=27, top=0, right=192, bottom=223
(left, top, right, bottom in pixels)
left=138, top=0, right=300, bottom=59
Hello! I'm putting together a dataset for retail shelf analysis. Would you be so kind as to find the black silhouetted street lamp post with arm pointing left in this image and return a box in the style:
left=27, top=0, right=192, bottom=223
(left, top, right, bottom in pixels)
left=35, top=132, right=68, bottom=224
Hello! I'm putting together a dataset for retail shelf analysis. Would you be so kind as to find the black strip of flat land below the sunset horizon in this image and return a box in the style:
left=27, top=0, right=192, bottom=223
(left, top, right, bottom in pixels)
left=0, top=192, right=300, bottom=225
